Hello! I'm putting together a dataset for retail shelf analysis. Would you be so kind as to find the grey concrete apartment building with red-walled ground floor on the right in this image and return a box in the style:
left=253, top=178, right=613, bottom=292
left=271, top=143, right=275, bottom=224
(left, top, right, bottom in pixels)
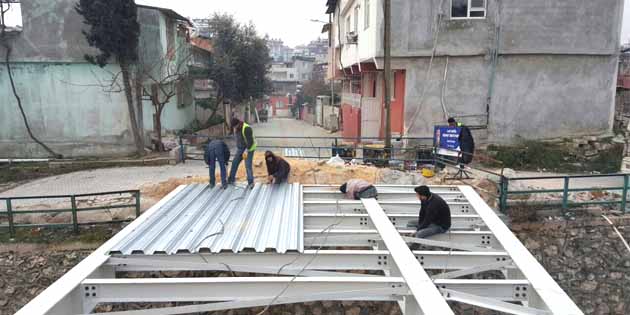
left=326, top=0, right=623, bottom=144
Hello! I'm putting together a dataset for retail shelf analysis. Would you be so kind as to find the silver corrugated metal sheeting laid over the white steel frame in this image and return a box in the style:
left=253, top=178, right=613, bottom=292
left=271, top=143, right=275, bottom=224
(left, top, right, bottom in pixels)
left=110, top=184, right=304, bottom=255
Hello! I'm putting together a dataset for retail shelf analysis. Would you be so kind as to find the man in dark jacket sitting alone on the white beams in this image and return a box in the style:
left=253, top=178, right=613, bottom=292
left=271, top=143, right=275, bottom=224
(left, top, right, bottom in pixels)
left=409, top=186, right=451, bottom=238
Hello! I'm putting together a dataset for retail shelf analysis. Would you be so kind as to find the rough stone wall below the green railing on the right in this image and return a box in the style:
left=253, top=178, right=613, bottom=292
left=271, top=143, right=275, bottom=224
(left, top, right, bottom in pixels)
left=512, top=216, right=630, bottom=315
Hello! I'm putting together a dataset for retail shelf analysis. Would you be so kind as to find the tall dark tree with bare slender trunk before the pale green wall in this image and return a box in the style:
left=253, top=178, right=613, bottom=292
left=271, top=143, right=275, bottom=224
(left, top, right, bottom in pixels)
left=75, top=0, right=144, bottom=155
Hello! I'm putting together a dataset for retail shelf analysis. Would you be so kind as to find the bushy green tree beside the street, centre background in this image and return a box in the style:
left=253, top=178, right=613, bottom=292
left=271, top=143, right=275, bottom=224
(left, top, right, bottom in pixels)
left=209, top=14, right=271, bottom=123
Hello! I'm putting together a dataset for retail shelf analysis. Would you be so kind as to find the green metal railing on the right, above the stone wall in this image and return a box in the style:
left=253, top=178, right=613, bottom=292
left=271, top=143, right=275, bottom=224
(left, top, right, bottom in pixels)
left=499, top=174, right=630, bottom=213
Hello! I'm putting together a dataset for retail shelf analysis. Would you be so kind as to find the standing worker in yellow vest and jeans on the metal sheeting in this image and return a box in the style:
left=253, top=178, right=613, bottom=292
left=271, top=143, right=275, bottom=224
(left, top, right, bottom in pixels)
left=228, top=118, right=256, bottom=189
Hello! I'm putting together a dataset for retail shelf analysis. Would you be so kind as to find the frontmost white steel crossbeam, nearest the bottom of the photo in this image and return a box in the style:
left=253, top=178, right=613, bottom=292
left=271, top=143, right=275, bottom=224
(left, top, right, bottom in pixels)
left=81, top=275, right=529, bottom=306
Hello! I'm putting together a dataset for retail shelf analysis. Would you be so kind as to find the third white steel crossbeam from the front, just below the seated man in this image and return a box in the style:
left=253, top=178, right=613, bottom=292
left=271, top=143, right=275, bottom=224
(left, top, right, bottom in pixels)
left=304, top=229, right=502, bottom=250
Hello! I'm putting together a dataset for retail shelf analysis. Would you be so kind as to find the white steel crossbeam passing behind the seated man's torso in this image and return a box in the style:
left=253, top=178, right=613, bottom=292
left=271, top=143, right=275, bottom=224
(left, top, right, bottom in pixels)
left=304, top=200, right=475, bottom=216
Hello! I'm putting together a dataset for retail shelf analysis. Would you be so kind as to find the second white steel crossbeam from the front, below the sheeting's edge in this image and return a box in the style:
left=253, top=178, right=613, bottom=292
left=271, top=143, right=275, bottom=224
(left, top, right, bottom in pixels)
left=107, top=250, right=509, bottom=271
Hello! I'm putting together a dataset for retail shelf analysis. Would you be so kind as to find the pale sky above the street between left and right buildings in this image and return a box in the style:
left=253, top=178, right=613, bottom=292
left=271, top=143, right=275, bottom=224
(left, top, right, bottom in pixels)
left=136, top=0, right=328, bottom=47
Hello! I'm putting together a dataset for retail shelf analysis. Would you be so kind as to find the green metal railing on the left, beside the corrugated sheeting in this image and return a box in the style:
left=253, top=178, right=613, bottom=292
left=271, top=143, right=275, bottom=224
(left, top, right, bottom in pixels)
left=0, top=190, right=140, bottom=238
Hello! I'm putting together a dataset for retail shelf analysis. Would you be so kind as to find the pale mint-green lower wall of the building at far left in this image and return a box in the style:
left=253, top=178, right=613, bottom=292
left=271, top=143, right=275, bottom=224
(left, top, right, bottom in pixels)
left=0, top=63, right=134, bottom=157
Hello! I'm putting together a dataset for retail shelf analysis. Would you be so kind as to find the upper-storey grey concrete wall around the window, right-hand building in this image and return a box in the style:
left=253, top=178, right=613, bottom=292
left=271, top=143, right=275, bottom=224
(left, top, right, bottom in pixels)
left=380, top=0, right=623, bottom=57
